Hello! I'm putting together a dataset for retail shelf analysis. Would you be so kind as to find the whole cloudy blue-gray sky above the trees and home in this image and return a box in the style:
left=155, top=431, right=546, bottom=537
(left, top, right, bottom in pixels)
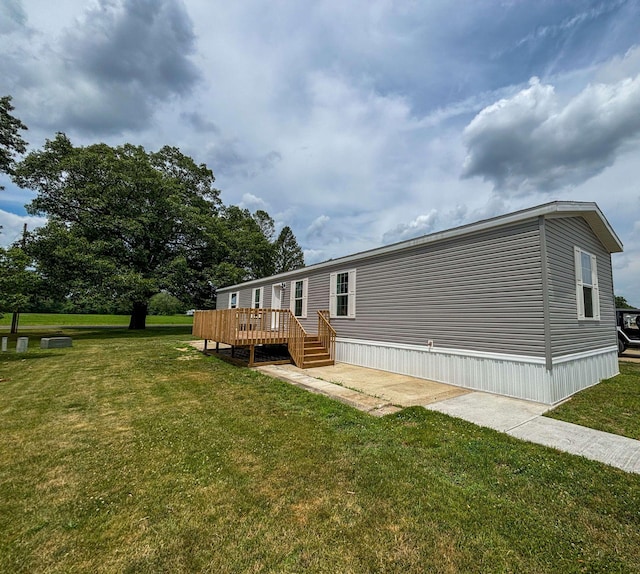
left=0, top=0, right=640, bottom=306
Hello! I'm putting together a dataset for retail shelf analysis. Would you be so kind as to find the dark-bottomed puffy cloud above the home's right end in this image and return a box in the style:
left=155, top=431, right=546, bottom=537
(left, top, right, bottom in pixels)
left=462, top=76, right=640, bottom=195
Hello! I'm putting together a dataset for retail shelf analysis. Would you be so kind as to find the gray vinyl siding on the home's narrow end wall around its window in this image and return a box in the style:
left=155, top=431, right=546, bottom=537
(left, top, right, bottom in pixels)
left=545, top=217, right=617, bottom=357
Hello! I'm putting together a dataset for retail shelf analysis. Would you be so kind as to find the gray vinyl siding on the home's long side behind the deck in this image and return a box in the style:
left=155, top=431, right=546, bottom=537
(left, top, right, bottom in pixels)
left=219, top=219, right=544, bottom=356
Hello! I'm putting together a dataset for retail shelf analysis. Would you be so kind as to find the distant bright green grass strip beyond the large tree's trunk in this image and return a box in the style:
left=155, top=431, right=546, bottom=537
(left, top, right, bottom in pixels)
left=0, top=313, right=193, bottom=330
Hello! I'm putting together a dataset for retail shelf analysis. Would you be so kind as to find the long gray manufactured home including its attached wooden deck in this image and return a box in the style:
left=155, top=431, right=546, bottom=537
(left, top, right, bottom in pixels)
left=194, top=201, right=622, bottom=404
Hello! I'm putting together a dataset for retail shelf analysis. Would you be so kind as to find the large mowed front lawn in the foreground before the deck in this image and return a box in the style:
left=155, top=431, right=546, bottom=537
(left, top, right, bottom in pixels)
left=0, top=328, right=640, bottom=573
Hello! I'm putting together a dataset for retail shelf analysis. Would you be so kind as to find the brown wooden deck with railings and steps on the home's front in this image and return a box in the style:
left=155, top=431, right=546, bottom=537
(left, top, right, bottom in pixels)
left=193, top=309, right=336, bottom=368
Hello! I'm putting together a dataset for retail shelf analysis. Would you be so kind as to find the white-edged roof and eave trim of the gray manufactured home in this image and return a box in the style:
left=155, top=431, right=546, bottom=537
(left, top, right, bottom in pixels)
left=218, top=201, right=622, bottom=291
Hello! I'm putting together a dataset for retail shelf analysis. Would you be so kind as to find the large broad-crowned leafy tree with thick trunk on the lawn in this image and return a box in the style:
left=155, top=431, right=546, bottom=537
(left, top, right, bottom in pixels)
left=14, top=134, right=220, bottom=329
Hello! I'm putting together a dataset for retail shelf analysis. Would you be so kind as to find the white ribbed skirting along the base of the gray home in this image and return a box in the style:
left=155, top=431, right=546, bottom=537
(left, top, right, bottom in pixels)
left=336, top=338, right=618, bottom=404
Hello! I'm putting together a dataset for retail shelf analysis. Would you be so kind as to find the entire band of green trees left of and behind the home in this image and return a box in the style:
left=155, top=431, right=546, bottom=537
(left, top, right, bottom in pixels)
left=0, top=96, right=304, bottom=329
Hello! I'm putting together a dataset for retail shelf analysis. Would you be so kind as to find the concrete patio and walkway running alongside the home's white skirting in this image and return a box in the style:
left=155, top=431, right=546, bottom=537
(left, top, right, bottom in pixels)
left=258, top=363, right=640, bottom=474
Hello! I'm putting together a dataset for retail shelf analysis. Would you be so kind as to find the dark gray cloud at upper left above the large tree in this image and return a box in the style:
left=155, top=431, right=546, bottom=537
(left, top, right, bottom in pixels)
left=31, top=0, right=199, bottom=134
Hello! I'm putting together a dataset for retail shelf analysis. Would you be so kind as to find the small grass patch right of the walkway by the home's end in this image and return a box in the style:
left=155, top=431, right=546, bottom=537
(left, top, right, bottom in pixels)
left=545, top=360, right=640, bottom=440
